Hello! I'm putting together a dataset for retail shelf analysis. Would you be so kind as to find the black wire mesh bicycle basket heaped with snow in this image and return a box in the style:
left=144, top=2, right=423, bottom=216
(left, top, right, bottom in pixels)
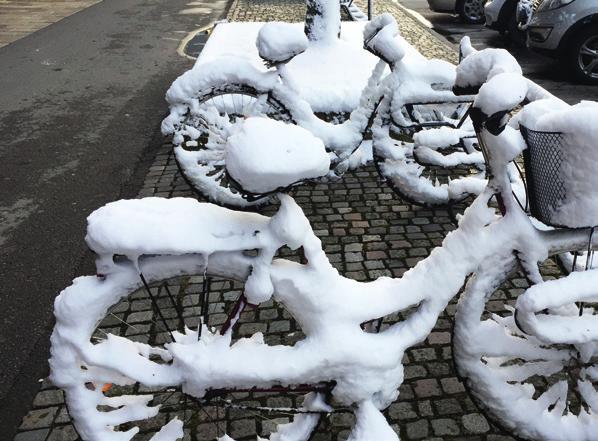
left=520, top=125, right=593, bottom=228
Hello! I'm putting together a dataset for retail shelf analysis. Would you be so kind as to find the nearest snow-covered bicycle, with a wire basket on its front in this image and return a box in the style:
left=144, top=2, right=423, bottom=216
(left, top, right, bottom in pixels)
left=50, top=51, right=598, bottom=441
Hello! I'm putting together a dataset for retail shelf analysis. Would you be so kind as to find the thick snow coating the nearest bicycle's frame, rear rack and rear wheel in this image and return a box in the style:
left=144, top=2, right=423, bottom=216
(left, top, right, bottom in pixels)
left=51, top=149, right=544, bottom=441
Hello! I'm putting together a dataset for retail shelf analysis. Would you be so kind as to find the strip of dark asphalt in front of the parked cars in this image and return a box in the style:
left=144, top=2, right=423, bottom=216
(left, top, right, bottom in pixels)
left=400, top=0, right=598, bottom=104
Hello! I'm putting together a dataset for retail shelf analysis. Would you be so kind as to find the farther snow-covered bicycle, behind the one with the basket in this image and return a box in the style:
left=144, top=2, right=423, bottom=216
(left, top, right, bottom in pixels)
left=162, top=12, right=485, bottom=206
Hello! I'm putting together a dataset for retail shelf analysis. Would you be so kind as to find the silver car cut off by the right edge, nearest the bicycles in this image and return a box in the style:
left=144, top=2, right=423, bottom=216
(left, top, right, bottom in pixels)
left=519, top=0, right=598, bottom=84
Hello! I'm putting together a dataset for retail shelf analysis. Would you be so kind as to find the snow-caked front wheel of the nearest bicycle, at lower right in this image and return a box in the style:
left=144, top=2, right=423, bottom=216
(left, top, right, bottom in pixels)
left=453, top=249, right=598, bottom=440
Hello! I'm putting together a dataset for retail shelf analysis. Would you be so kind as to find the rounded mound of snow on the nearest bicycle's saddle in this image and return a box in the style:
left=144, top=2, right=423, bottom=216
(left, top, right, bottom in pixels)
left=226, top=118, right=330, bottom=193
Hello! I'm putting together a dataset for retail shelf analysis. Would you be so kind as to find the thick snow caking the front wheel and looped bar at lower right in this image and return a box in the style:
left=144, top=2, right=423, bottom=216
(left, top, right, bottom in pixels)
left=454, top=253, right=598, bottom=441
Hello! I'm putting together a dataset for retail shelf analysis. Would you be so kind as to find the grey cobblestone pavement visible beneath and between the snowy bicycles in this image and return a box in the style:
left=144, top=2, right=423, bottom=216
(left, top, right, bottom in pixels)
left=15, top=0, right=522, bottom=441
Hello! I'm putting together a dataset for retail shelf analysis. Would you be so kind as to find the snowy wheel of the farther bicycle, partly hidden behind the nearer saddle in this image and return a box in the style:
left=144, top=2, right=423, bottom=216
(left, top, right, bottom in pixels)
left=173, top=84, right=292, bottom=207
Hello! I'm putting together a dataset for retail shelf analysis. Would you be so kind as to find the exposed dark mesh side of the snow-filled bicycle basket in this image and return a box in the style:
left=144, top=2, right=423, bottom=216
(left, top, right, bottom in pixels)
left=520, top=126, right=567, bottom=227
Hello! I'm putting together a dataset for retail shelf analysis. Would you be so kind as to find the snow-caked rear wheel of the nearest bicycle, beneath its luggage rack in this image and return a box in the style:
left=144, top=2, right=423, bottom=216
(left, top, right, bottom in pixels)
left=50, top=257, right=320, bottom=441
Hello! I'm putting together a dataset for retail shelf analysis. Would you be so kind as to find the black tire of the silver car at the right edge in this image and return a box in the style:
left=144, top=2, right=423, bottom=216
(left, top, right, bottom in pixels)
left=565, top=26, right=598, bottom=84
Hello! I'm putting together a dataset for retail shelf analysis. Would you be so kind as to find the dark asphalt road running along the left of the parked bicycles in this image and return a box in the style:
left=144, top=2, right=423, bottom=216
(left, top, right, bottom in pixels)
left=0, top=0, right=226, bottom=439
